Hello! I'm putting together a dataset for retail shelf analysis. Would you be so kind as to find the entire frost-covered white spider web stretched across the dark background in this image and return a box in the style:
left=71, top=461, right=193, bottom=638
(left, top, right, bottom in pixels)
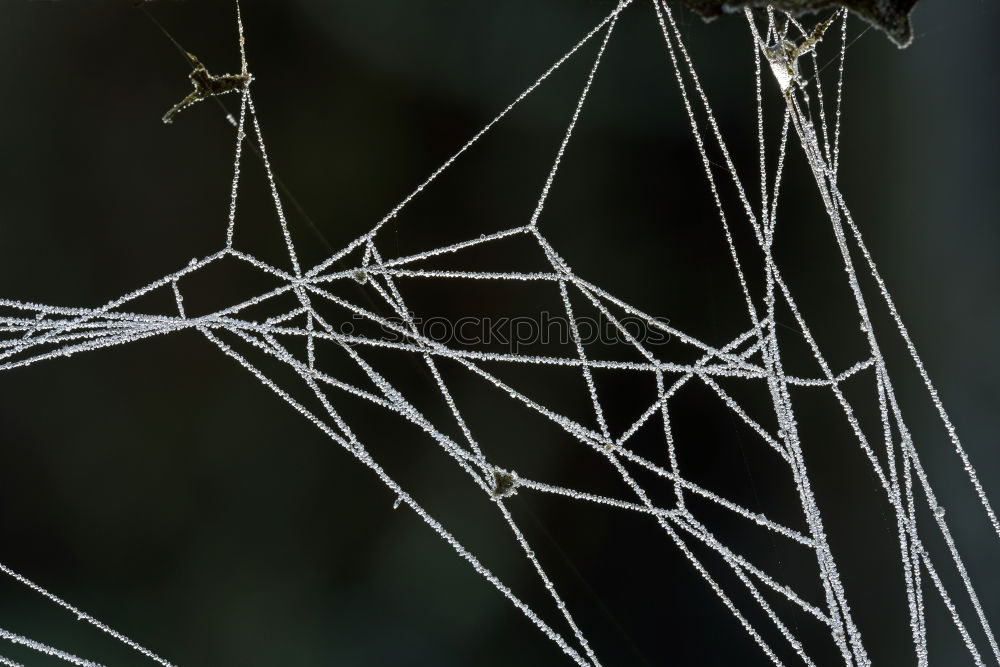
left=0, top=0, right=1000, bottom=665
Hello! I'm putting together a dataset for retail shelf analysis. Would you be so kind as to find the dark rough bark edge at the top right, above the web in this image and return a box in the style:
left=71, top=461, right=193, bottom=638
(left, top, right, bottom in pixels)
left=677, top=0, right=917, bottom=47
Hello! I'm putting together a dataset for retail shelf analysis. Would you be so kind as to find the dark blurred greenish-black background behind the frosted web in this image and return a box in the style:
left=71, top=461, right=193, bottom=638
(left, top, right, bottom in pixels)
left=0, top=0, right=1000, bottom=666
